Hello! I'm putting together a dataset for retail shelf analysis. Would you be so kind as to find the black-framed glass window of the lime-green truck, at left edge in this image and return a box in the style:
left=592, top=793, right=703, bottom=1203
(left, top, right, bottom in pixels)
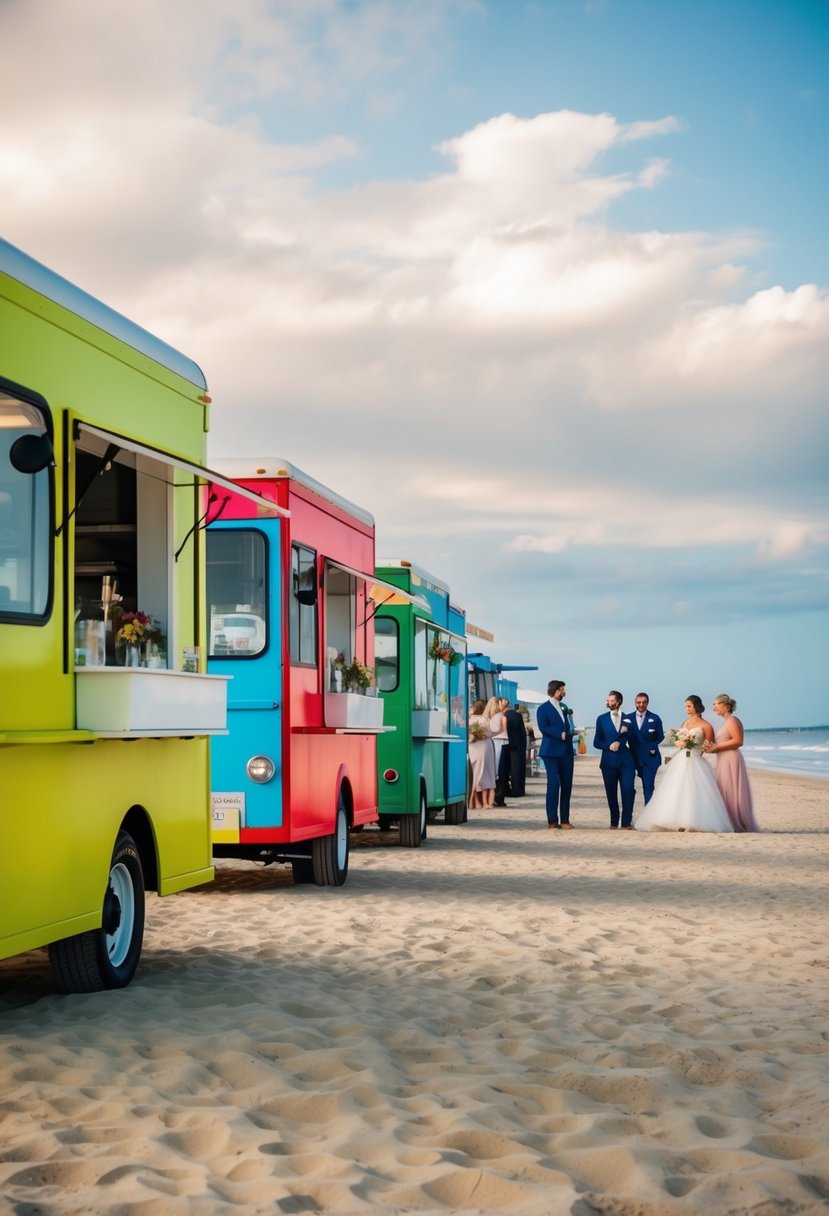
left=0, top=383, right=52, bottom=624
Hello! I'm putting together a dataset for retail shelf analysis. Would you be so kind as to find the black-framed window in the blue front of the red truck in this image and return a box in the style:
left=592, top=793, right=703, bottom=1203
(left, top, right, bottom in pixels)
left=207, top=529, right=267, bottom=659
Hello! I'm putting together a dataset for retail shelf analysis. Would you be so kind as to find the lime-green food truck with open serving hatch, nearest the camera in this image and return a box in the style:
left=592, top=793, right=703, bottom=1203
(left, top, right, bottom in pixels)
left=0, top=234, right=267, bottom=991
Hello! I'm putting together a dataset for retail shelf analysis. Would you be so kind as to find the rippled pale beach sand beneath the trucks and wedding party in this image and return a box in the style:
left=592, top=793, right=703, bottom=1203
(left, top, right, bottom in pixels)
left=0, top=756, right=829, bottom=1216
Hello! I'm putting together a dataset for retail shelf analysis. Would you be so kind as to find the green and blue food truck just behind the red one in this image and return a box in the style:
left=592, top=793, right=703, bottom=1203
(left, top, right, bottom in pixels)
left=374, top=561, right=468, bottom=848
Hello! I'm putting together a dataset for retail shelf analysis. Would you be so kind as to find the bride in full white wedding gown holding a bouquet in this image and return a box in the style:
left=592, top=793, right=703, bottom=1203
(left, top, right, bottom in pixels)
left=633, top=697, right=734, bottom=832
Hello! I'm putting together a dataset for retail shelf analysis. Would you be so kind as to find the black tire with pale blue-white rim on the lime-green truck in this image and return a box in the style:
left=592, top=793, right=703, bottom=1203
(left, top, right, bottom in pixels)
left=49, top=832, right=143, bottom=992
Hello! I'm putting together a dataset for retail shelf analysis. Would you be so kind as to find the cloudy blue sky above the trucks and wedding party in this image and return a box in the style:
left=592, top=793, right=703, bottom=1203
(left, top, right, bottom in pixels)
left=0, top=0, right=829, bottom=728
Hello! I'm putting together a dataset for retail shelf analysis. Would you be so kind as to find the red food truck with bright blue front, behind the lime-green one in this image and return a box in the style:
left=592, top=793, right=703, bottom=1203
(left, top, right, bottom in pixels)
left=207, top=460, right=415, bottom=886
